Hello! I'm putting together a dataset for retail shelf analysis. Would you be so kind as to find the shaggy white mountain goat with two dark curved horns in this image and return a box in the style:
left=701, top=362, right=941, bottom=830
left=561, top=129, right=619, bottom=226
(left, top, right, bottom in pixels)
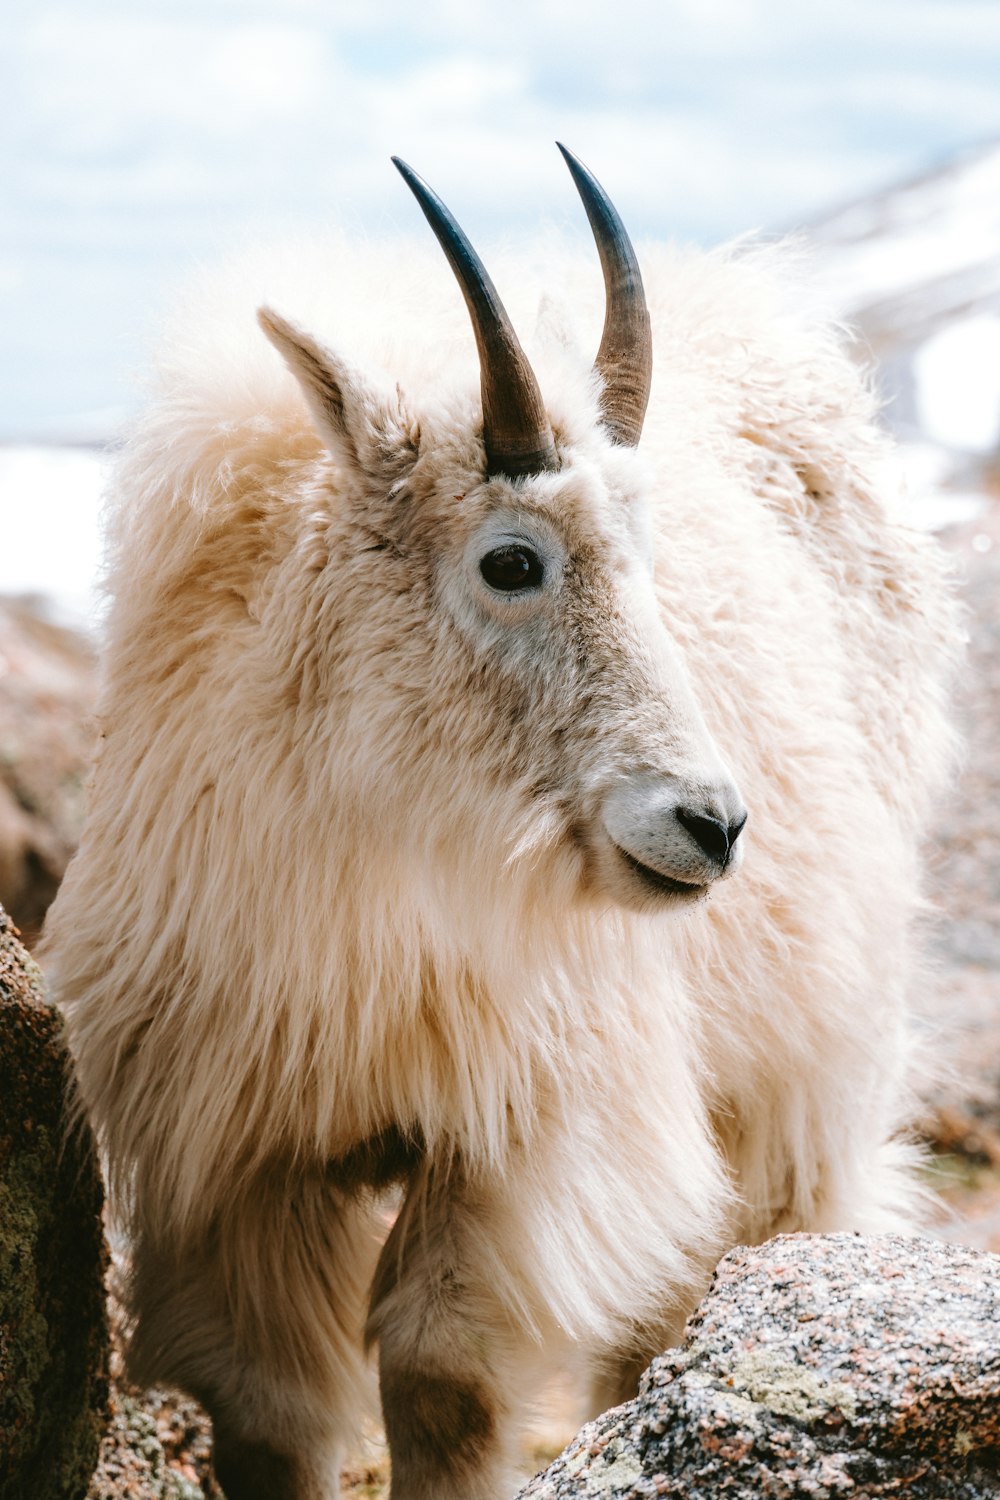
left=48, top=143, right=958, bottom=1500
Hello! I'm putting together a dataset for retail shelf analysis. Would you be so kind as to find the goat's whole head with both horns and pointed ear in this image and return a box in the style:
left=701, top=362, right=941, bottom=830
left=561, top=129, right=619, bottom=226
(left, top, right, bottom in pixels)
left=259, top=147, right=747, bottom=911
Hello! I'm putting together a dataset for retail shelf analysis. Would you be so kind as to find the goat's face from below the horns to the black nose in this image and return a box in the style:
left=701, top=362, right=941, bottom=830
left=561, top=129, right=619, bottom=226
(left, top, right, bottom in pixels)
left=435, top=446, right=745, bottom=908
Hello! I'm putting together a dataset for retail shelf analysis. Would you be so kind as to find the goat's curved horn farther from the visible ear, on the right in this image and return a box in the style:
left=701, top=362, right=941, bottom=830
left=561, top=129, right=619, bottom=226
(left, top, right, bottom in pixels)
left=556, top=141, right=652, bottom=449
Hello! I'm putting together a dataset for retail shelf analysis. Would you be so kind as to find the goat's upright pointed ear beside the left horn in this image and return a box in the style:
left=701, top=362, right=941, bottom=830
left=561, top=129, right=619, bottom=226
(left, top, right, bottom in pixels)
left=256, top=308, right=420, bottom=477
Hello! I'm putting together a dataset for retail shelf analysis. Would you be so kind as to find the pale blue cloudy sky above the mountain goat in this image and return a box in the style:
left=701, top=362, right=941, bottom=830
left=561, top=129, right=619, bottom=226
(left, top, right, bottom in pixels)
left=0, top=0, right=1000, bottom=438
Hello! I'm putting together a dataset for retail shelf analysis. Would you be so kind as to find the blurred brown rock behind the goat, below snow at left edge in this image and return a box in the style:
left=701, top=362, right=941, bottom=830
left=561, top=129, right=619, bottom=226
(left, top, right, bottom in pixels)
left=0, top=599, right=97, bottom=947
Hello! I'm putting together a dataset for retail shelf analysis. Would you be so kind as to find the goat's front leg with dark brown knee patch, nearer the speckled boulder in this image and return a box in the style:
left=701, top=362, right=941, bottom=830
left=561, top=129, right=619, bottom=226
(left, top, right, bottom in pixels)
left=369, top=1169, right=537, bottom=1500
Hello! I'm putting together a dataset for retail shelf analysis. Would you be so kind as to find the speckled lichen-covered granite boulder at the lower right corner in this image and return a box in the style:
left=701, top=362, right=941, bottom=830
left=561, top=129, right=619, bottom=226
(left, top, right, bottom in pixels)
left=519, top=1235, right=1000, bottom=1500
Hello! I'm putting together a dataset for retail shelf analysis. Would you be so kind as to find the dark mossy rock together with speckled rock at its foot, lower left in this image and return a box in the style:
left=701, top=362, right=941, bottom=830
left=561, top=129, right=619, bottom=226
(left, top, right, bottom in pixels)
left=0, top=908, right=220, bottom=1500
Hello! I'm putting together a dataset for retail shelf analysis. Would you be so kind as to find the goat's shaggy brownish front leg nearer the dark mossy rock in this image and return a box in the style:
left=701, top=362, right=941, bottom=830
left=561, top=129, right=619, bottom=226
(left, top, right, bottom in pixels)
left=122, top=1172, right=378, bottom=1500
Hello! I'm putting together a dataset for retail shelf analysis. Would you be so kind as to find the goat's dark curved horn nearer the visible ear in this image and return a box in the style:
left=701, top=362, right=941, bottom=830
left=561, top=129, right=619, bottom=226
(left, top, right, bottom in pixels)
left=393, top=156, right=559, bottom=479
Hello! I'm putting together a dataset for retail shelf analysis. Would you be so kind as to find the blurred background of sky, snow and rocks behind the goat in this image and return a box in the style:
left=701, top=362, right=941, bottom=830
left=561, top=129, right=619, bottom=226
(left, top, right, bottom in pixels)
left=0, top=0, right=1000, bottom=1224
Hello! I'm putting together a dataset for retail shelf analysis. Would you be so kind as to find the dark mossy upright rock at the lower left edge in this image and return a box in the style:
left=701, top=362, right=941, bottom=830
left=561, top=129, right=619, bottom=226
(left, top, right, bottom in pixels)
left=0, top=909, right=108, bottom=1500
